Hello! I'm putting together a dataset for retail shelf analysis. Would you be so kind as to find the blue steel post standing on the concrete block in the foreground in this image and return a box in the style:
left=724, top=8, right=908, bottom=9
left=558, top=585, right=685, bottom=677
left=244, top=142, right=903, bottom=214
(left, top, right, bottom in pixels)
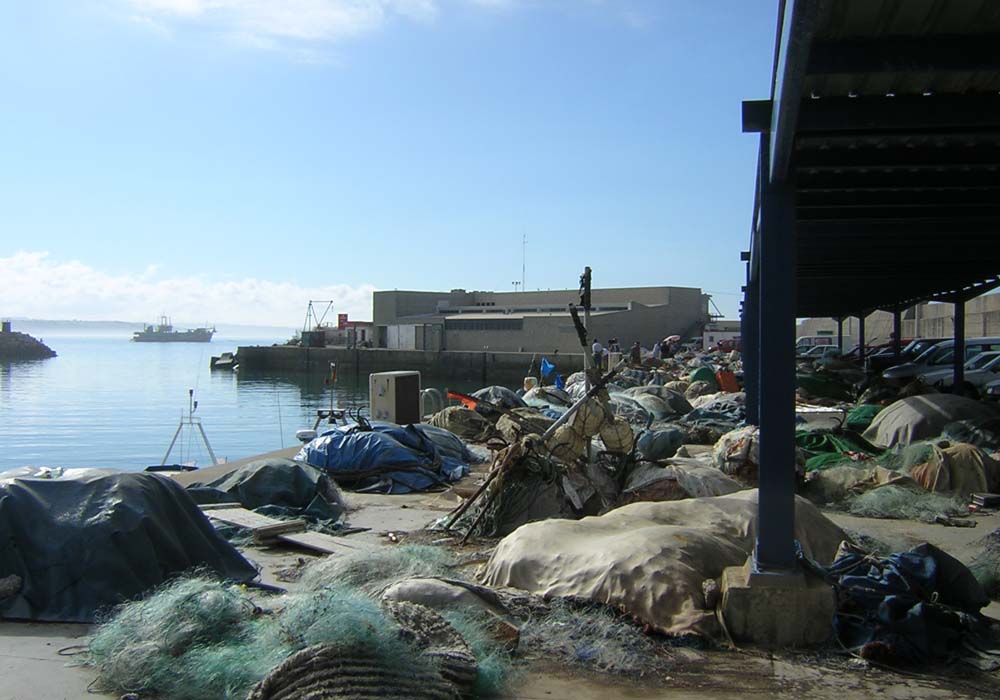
left=754, top=134, right=796, bottom=572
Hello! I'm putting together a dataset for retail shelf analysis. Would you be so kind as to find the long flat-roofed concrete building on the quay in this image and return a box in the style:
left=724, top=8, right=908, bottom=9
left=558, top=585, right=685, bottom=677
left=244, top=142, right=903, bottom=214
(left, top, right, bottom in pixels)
left=372, top=287, right=709, bottom=353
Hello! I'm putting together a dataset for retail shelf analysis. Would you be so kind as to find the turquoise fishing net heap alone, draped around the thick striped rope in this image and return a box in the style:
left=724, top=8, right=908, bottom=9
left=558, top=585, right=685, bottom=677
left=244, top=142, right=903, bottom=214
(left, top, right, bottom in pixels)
left=87, top=547, right=508, bottom=700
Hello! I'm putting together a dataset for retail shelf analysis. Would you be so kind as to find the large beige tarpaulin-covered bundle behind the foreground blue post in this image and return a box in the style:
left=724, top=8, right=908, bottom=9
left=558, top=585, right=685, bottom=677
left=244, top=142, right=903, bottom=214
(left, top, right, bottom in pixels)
left=483, top=490, right=845, bottom=636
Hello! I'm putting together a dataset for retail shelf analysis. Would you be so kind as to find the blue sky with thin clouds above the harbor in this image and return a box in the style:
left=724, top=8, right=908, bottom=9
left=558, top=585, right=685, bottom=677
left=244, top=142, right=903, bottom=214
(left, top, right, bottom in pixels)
left=0, top=0, right=777, bottom=325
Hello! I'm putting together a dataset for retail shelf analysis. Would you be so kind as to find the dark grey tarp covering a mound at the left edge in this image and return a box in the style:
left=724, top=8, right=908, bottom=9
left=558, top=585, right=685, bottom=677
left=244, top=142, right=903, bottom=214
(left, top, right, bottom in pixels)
left=0, top=469, right=257, bottom=622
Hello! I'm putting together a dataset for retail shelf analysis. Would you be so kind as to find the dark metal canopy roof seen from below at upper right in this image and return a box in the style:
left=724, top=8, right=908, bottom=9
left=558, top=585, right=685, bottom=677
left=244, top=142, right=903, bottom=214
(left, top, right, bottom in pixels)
left=743, top=0, right=1000, bottom=317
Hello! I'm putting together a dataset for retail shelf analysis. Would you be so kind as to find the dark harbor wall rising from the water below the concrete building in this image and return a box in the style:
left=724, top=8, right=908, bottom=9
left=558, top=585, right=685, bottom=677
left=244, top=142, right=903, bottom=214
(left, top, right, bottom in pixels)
left=237, top=345, right=583, bottom=386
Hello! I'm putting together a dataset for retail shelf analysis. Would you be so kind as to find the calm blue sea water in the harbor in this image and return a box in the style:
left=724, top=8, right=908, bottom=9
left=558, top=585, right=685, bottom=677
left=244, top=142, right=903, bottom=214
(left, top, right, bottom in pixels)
left=0, top=329, right=475, bottom=471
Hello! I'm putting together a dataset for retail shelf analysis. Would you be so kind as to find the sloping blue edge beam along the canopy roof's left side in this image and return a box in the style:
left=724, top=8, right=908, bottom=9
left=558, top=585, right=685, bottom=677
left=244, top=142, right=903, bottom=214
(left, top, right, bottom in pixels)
left=766, top=0, right=828, bottom=182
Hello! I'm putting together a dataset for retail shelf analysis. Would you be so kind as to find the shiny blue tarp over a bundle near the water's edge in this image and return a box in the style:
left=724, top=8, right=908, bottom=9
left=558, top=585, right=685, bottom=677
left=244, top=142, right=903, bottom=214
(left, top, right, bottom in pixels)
left=295, top=423, right=469, bottom=493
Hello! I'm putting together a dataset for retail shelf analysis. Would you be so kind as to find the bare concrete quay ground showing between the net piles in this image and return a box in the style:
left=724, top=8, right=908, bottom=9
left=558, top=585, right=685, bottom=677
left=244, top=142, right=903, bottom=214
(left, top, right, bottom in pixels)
left=0, top=484, right=1000, bottom=700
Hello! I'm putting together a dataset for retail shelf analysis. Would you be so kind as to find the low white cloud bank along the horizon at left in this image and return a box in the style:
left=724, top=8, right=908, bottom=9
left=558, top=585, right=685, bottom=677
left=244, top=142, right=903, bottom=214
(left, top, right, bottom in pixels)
left=0, top=251, right=375, bottom=326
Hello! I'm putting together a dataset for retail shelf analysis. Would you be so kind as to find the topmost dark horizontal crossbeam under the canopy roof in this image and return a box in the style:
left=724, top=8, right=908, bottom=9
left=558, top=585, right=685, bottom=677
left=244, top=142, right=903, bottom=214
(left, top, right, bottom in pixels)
left=808, top=34, right=1000, bottom=75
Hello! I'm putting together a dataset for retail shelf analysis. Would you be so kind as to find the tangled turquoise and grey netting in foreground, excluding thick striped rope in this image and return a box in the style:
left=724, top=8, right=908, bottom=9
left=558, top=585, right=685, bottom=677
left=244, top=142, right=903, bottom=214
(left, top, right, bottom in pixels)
left=85, top=546, right=680, bottom=700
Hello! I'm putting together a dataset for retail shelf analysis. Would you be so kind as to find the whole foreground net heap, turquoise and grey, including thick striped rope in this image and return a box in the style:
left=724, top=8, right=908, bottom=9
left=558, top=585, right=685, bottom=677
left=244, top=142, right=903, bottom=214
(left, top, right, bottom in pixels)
left=86, top=546, right=669, bottom=700
